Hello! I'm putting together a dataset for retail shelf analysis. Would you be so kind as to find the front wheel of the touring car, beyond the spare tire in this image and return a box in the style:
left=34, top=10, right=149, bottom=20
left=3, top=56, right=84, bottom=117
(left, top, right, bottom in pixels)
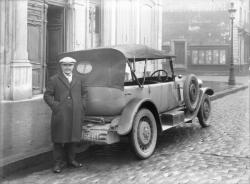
left=197, top=94, right=211, bottom=128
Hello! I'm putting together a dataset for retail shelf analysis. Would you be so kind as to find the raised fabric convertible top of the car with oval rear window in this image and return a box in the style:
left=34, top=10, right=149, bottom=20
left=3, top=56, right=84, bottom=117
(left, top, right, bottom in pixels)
left=59, top=44, right=175, bottom=90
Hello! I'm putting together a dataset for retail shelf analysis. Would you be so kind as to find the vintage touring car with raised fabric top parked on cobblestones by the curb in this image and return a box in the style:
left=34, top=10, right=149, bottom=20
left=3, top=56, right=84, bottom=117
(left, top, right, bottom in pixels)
left=60, top=45, right=213, bottom=159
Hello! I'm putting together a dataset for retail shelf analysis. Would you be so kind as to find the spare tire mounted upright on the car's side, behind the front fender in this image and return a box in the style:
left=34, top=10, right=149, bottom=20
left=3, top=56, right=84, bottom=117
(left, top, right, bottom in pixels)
left=183, top=74, right=200, bottom=112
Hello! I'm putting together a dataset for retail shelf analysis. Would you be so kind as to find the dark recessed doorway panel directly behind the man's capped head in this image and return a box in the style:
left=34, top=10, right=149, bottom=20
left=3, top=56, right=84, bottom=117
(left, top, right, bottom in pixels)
left=47, top=6, right=65, bottom=77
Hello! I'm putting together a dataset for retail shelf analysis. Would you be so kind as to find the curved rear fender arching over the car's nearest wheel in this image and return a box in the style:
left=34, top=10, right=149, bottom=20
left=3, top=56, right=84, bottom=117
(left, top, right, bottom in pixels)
left=117, top=98, right=161, bottom=135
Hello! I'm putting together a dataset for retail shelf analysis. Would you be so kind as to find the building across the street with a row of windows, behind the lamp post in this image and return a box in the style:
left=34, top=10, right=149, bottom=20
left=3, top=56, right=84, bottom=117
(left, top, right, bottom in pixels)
left=162, top=0, right=249, bottom=75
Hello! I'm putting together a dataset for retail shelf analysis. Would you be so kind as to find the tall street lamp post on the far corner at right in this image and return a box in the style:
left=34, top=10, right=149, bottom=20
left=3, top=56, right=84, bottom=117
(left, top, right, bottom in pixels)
left=228, top=2, right=236, bottom=85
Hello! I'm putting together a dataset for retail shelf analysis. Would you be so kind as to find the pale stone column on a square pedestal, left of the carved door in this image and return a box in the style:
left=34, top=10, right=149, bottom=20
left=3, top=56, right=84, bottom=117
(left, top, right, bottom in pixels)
left=10, top=0, right=32, bottom=100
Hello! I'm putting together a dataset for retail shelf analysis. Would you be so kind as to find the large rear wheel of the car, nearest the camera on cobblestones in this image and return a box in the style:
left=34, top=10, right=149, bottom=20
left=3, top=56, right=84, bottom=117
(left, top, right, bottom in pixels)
left=130, top=109, right=157, bottom=159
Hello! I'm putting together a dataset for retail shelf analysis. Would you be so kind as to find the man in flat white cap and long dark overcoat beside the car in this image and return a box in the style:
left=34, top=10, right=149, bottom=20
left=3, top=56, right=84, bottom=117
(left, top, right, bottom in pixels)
left=44, top=57, right=87, bottom=173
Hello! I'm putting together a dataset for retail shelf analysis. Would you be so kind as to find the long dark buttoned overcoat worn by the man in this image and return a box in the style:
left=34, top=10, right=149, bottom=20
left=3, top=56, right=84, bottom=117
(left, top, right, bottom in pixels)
left=44, top=72, right=87, bottom=143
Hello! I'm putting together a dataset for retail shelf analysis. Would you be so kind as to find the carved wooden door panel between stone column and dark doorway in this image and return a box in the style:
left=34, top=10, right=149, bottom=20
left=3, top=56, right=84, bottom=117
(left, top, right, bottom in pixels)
left=27, top=0, right=46, bottom=94
